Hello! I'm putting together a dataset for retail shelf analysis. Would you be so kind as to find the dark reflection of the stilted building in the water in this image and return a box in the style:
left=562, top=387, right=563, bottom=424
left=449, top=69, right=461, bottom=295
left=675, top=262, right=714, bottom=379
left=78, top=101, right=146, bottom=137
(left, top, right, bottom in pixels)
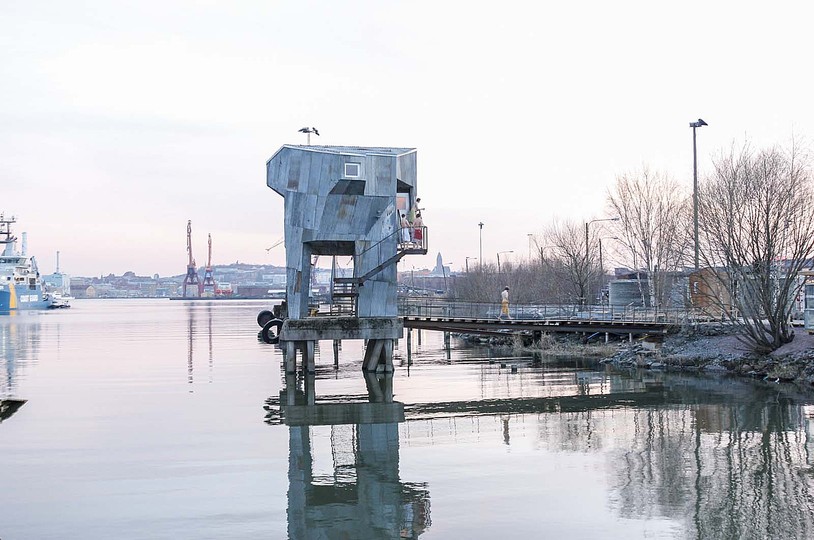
left=266, top=373, right=430, bottom=538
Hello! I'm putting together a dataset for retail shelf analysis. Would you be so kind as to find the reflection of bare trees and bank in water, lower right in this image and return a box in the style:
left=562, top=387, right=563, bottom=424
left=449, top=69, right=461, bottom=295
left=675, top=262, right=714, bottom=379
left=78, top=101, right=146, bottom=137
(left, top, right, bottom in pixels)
left=538, top=374, right=814, bottom=538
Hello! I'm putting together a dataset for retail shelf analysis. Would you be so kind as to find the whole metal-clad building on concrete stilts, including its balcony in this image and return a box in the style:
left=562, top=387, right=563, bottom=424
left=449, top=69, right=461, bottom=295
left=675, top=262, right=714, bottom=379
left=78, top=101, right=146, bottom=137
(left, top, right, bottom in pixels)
left=266, top=145, right=427, bottom=373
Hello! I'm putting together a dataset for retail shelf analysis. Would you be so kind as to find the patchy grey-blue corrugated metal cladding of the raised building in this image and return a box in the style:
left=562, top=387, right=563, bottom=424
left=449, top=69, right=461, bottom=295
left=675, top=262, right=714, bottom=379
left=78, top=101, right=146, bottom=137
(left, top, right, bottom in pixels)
left=266, top=145, right=417, bottom=319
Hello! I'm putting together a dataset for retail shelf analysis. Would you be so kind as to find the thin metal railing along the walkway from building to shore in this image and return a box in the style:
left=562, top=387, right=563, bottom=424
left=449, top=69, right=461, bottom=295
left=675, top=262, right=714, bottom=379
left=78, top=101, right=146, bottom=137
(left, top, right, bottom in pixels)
left=399, top=297, right=695, bottom=325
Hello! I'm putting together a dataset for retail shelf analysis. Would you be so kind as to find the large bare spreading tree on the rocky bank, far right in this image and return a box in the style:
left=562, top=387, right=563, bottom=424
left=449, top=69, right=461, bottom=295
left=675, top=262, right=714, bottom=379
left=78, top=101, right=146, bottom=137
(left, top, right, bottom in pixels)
left=699, top=143, right=814, bottom=353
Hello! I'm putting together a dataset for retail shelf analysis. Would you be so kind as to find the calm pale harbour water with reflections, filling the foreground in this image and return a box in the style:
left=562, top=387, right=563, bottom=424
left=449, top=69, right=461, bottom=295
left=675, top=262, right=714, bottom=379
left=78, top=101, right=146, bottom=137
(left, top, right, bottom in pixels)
left=0, top=300, right=814, bottom=540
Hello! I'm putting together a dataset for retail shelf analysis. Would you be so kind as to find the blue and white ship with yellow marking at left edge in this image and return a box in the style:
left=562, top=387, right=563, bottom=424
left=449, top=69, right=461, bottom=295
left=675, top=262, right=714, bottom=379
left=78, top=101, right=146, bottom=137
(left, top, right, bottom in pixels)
left=0, top=214, right=52, bottom=314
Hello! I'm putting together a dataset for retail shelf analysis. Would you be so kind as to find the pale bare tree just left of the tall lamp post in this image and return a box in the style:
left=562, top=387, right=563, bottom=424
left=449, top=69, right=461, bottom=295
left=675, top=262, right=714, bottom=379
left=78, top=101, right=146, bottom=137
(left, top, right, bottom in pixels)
left=608, top=166, right=691, bottom=306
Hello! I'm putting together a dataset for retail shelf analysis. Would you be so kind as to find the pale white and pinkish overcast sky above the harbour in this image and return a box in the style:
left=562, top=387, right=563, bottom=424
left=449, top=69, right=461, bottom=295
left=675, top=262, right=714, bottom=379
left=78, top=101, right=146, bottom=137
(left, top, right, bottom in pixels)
left=0, top=0, right=814, bottom=276
